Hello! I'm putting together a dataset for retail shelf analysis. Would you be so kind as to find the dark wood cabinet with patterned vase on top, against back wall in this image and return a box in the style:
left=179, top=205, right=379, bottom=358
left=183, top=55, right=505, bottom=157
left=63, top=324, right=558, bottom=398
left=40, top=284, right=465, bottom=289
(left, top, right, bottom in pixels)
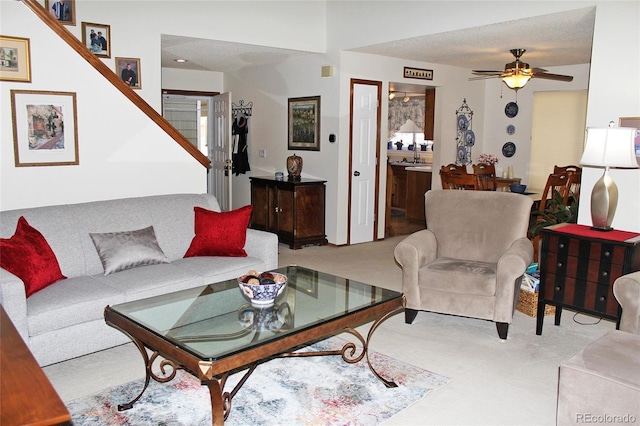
left=250, top=177, right=327, bottom=249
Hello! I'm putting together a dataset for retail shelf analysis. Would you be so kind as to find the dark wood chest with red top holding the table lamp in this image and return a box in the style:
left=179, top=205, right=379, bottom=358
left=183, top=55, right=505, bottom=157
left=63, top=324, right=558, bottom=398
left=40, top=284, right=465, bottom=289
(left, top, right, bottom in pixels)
left=536, top=223, right=640, bottom=335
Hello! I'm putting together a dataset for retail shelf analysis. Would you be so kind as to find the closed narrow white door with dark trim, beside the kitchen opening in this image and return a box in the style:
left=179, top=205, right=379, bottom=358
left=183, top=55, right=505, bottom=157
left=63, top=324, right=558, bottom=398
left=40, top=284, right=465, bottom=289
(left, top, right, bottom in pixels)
left=349, top=84, right=379, bottom=244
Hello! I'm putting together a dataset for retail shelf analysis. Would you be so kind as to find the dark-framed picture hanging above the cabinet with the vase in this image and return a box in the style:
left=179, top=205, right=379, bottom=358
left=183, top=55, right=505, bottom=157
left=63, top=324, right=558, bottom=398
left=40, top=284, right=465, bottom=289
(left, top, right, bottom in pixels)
left=288, top=96, right=320, bottom=151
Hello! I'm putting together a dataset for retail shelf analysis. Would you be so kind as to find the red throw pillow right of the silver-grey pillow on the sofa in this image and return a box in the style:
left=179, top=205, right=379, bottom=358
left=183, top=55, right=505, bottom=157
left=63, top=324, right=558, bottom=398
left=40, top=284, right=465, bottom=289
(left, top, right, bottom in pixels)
left=184, top=206, right=251, bottom=257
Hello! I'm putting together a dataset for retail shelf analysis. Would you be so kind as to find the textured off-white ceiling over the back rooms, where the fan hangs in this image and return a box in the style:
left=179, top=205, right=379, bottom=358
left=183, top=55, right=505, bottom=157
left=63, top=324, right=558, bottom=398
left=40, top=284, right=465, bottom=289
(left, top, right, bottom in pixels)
left=162, top=8, right=595, bottom=78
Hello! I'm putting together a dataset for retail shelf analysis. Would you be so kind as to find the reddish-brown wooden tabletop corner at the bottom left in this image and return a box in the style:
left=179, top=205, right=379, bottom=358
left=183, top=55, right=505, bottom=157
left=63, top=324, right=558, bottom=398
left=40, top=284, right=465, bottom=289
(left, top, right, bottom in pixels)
left=0, top=306, right=71, bottom=426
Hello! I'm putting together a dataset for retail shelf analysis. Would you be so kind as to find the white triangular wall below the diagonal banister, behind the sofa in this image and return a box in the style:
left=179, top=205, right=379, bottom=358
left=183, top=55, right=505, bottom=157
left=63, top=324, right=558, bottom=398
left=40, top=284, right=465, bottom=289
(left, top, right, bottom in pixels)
left=0, top=1, right=206, bottom=210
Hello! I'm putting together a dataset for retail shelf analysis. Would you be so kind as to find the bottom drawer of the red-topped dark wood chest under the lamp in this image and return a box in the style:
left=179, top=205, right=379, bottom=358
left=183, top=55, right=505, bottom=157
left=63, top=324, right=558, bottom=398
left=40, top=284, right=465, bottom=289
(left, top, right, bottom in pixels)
left=544, top=273, right=618, bottom=317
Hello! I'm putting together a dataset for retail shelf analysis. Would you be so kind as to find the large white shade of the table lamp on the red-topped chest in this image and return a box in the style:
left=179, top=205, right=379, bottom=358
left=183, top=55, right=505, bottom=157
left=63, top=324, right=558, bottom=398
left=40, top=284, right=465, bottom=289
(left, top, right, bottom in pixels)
left=580, top=127, right=638, bottom=169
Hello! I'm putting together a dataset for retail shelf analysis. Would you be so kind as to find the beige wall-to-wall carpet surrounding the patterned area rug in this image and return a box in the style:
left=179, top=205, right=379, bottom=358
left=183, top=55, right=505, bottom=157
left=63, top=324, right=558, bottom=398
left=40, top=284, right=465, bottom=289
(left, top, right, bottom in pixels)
left=44, top=236, right=615, bottom=426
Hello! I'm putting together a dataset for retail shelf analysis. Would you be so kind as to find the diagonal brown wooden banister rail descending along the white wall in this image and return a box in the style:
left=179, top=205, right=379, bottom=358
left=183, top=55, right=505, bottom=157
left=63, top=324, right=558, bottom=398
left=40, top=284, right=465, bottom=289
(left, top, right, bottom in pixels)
left=21, top=0, right=211, bottom=168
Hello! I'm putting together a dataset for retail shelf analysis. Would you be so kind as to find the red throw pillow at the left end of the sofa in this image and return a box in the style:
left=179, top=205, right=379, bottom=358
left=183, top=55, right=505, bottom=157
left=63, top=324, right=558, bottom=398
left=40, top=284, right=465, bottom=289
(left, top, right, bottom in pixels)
left=0, top=216, right=67, bottom=297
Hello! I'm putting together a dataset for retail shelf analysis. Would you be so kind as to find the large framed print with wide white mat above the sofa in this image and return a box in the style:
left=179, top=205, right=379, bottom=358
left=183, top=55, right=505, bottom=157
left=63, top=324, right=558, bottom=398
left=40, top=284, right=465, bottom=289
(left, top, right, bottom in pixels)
left=11, top=90, right=79, bottom=167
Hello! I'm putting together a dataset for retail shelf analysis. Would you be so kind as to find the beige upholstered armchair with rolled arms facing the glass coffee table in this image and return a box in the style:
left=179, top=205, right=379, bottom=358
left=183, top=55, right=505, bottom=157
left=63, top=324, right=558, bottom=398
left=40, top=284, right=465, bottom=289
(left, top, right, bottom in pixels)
left=395, top=190, right=533, bottom=339
